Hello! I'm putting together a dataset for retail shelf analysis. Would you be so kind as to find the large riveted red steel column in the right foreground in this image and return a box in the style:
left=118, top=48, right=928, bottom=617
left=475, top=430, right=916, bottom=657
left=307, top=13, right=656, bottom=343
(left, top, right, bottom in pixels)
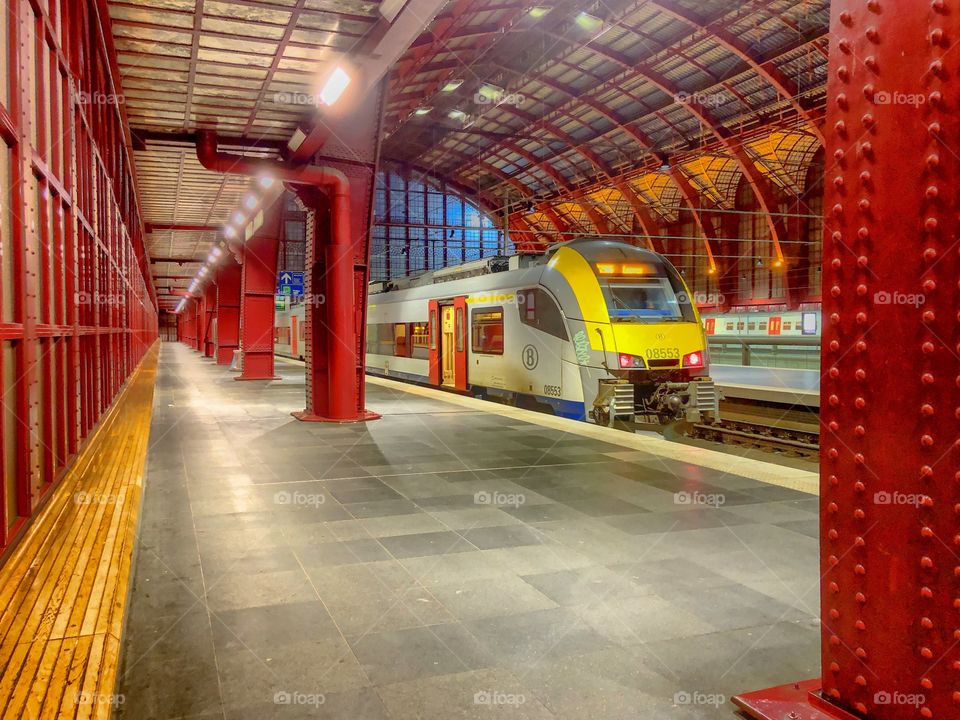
left=736, top=0, right=960, bottom=720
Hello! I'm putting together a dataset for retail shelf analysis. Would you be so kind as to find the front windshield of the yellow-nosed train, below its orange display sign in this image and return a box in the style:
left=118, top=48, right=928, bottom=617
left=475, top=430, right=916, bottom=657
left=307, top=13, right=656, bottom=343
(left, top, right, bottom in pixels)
left=601, top=277, right=695, bottom=322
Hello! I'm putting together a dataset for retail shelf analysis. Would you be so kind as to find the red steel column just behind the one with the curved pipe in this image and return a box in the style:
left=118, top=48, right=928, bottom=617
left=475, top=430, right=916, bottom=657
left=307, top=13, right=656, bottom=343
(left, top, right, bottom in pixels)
left=235, top=202, right=283, bottom=380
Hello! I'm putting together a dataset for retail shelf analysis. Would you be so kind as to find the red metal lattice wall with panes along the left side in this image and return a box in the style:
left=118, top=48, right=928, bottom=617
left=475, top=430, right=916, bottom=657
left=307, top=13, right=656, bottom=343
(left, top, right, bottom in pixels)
left=0, top=0, right=158, bottom=548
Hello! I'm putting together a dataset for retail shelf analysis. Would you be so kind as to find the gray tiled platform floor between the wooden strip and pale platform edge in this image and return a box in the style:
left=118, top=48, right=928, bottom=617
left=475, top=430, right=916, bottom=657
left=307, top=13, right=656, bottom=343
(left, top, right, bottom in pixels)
left=112, top=344, right=819, bottom=720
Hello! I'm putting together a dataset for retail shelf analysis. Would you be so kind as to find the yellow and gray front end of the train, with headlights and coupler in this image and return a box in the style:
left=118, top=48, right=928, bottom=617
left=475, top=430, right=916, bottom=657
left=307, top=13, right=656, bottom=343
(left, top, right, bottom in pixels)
left=542, top=240, right=719, bottom=425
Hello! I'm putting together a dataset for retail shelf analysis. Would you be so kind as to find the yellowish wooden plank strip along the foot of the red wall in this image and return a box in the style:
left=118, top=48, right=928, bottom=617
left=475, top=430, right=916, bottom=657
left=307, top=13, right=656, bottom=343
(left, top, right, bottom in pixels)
left=0, top=343, right=160, bottom=720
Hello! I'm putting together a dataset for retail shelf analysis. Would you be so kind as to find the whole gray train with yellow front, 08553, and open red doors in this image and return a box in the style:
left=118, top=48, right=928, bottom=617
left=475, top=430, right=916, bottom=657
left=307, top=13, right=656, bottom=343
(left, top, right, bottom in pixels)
left=275, top=239, right=719, bottom=425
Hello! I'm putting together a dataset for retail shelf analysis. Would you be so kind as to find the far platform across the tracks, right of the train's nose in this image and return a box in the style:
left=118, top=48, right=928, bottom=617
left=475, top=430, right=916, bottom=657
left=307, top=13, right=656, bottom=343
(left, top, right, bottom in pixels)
left=710, top=364, right=820, bottom=408
